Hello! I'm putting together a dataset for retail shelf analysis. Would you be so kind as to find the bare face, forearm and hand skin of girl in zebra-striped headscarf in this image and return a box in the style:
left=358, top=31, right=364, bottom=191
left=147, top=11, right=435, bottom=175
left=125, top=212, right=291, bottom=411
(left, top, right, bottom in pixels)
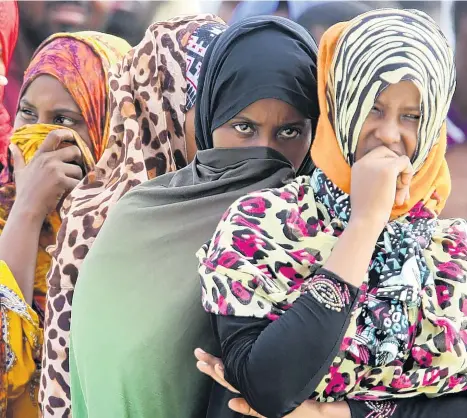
left=195, top=81, right=420, bottom=418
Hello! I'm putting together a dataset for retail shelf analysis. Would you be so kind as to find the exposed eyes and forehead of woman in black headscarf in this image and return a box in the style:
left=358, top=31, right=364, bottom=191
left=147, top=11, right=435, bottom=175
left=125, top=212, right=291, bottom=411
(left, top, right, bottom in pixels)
left=212, top=99, right=311, bottom=169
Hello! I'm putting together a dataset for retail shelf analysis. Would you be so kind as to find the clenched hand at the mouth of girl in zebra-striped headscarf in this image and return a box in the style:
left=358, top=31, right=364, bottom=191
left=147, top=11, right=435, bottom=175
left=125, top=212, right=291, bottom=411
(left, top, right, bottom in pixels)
left=350, top=146, right=414, bottom=232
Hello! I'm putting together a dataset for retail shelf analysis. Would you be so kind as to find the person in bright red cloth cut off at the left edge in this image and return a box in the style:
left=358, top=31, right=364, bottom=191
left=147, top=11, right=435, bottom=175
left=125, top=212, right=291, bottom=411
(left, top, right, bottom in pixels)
left=0, top=1, right=18, bottom=184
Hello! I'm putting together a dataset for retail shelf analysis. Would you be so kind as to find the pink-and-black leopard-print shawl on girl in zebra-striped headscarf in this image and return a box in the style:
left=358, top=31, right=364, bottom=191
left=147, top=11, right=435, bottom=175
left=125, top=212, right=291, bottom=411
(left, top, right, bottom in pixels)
left=198, top=169, right=467, bottom=402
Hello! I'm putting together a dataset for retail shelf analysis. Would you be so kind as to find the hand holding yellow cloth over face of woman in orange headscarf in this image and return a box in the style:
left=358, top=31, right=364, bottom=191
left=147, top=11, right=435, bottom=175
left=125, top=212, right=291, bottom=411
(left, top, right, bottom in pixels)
left=10, top=129, right=83, bottom=222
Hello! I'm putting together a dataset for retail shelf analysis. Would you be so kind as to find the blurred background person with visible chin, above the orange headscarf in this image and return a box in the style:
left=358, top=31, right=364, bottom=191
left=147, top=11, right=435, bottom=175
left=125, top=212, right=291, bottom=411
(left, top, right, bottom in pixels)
left=4, top=0, right=112, bottom=121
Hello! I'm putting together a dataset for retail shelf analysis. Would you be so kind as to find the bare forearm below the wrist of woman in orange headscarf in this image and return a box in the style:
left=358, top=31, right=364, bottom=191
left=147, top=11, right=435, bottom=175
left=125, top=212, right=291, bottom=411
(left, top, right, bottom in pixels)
left=0, top=202, right=43, bottom=304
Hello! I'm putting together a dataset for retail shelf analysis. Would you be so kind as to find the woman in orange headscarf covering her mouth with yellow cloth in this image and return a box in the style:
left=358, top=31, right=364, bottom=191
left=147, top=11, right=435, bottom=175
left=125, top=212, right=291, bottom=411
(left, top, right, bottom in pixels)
left=0, top=32, right=130, bottom=418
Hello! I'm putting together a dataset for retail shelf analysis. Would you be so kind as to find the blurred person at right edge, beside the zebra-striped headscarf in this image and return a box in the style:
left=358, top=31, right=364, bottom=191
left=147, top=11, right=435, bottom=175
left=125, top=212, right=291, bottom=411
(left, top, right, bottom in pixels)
left=443, top=1, right=467, bottom=219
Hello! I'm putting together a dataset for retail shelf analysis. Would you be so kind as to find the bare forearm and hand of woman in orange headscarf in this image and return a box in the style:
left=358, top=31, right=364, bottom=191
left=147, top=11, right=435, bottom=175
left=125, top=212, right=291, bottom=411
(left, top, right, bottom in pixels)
left=0, top=130, right=82, bottom=305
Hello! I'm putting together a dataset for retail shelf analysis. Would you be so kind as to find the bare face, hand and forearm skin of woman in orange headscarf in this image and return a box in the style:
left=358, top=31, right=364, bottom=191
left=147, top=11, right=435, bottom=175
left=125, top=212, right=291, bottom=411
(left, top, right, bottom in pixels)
left=0, top=75, right=87, bottom=304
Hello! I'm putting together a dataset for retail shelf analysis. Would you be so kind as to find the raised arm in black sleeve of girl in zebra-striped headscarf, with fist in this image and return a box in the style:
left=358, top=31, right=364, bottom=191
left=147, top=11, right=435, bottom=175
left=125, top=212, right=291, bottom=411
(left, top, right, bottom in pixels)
left=203, top=147, right=411, bottom=418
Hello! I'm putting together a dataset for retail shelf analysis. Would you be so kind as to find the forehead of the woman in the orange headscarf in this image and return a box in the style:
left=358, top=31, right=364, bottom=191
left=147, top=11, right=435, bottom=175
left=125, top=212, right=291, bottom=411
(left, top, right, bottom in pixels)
left=21, top=75, right=80, bottom=112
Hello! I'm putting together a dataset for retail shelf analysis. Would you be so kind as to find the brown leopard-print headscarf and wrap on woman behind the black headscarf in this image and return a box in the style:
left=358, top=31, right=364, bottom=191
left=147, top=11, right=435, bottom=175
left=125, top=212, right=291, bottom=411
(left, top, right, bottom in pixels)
left=40, top=15, right=224, bottom=418
